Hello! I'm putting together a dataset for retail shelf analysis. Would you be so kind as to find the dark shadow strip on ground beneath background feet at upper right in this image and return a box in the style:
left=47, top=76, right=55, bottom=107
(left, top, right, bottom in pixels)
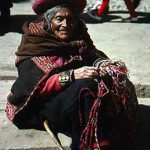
left=83, top=11, right=150, bottom=24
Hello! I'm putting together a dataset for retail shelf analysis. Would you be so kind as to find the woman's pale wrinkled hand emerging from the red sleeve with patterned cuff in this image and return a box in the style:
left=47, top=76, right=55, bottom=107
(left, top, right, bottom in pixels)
left=74, top=66, right=99, bottom=79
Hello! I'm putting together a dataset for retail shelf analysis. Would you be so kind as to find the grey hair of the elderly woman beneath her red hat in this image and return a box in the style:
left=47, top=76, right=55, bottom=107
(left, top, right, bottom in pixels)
left=44, top=4, right=79, bottom=33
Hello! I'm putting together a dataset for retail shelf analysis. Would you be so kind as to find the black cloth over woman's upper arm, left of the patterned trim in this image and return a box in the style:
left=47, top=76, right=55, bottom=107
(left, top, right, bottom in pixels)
left=8, top=59, right=44, bottom=105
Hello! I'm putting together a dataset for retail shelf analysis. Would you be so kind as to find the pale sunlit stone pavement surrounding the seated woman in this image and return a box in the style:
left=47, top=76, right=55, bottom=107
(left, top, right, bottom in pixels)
left=0, top=0, right=150, bottom=150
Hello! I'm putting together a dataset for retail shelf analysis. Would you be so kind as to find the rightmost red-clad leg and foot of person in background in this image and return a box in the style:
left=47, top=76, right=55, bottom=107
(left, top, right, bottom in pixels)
left=122, top=0, right=138, bottom=22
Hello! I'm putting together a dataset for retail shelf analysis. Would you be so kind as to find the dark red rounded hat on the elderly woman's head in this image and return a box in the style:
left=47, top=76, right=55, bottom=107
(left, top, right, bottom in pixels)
left=32, top=0, right=86, bottom=15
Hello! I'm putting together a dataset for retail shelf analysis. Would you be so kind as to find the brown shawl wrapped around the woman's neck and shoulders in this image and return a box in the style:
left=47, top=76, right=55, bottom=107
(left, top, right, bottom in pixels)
left=16, top=21, right=107, bottom=64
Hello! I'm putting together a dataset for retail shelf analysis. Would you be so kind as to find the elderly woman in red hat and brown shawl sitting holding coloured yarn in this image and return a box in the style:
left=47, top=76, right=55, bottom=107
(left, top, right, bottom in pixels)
left=6, top=0, right=140, bottom=150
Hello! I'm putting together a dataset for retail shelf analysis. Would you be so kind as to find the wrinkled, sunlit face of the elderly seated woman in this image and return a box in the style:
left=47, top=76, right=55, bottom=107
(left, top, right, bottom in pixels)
left=50, top=7, right=76, bottom=41
